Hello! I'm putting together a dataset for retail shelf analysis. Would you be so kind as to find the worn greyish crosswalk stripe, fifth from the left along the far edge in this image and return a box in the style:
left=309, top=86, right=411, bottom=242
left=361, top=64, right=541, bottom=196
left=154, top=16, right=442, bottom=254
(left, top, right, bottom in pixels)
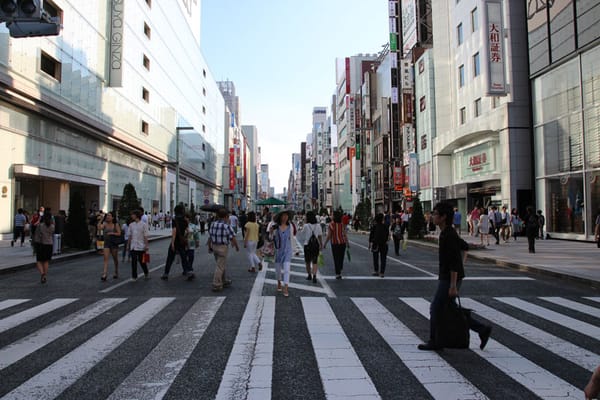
left=108, top=297, right=225, bottom=400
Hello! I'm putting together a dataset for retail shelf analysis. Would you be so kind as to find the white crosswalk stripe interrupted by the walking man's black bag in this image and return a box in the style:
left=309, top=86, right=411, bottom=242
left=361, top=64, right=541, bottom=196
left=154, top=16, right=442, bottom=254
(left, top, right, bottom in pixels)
left=400, top=297, right=581, bottom=399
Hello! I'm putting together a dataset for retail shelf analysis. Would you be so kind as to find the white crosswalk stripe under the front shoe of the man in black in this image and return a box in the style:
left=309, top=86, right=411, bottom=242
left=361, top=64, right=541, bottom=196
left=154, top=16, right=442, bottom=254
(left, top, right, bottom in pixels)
left=352, top=297, right=487, bottom=399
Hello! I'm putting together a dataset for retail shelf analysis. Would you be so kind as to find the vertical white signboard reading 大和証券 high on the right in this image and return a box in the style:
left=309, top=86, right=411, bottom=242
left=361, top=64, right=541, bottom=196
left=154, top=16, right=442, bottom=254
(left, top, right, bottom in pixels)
left=484, top=0, right=507, bottom=96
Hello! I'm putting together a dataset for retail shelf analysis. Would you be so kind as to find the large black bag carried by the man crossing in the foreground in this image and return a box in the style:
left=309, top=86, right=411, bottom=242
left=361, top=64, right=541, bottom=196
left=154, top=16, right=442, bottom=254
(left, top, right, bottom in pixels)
left=435, top=298, right=471, bottom=349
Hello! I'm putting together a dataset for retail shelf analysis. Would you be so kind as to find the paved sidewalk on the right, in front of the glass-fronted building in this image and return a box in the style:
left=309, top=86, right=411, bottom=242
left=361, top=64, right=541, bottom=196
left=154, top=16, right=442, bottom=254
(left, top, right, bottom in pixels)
left=409, top=234, right=600, bottom=288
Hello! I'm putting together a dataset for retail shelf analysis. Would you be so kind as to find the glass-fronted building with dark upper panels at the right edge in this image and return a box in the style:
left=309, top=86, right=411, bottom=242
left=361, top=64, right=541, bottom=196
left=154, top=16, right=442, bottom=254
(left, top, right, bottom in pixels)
left=528, top=0, right=600, bottom=240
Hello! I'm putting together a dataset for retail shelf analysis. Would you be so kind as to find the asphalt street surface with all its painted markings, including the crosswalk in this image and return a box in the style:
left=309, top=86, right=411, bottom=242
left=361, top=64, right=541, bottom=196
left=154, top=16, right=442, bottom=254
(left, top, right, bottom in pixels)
left=0, top=234, right=600, bottom=400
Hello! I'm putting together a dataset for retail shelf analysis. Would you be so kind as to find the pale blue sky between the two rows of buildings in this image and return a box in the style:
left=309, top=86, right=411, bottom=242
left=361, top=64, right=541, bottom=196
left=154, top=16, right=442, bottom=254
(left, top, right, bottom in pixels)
left=201, top=0, right=389, bottom=193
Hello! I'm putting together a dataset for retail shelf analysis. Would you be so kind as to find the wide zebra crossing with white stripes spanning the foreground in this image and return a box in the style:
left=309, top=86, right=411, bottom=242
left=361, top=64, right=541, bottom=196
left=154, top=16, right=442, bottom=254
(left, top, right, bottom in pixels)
left=0, top=292, right=600, bottom=400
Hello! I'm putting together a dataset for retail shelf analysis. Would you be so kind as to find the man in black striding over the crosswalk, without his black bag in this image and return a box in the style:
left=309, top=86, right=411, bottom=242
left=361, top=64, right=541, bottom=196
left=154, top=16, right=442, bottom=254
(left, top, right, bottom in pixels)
left=418, top=202, right=492, bottom=350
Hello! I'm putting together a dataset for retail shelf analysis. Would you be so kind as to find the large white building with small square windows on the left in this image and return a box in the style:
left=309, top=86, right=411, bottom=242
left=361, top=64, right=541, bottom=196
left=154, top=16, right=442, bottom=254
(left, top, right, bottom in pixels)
left=0, top=0, right=226, bottom=234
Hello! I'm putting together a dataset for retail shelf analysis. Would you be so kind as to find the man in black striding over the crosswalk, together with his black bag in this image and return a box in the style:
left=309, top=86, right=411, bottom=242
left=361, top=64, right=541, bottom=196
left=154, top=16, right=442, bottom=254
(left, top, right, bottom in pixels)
left=418, top=202, right=492, bottom=350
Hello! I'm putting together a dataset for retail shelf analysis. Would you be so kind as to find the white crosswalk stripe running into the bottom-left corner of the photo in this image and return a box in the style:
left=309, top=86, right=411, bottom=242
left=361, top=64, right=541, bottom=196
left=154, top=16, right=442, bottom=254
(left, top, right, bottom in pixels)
left=2, top=297, right=175, bottom=400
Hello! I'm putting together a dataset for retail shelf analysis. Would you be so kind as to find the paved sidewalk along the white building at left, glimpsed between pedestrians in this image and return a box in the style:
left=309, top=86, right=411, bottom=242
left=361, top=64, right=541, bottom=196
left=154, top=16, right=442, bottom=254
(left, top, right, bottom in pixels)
left=0, top=229, right=171, bottom=274
